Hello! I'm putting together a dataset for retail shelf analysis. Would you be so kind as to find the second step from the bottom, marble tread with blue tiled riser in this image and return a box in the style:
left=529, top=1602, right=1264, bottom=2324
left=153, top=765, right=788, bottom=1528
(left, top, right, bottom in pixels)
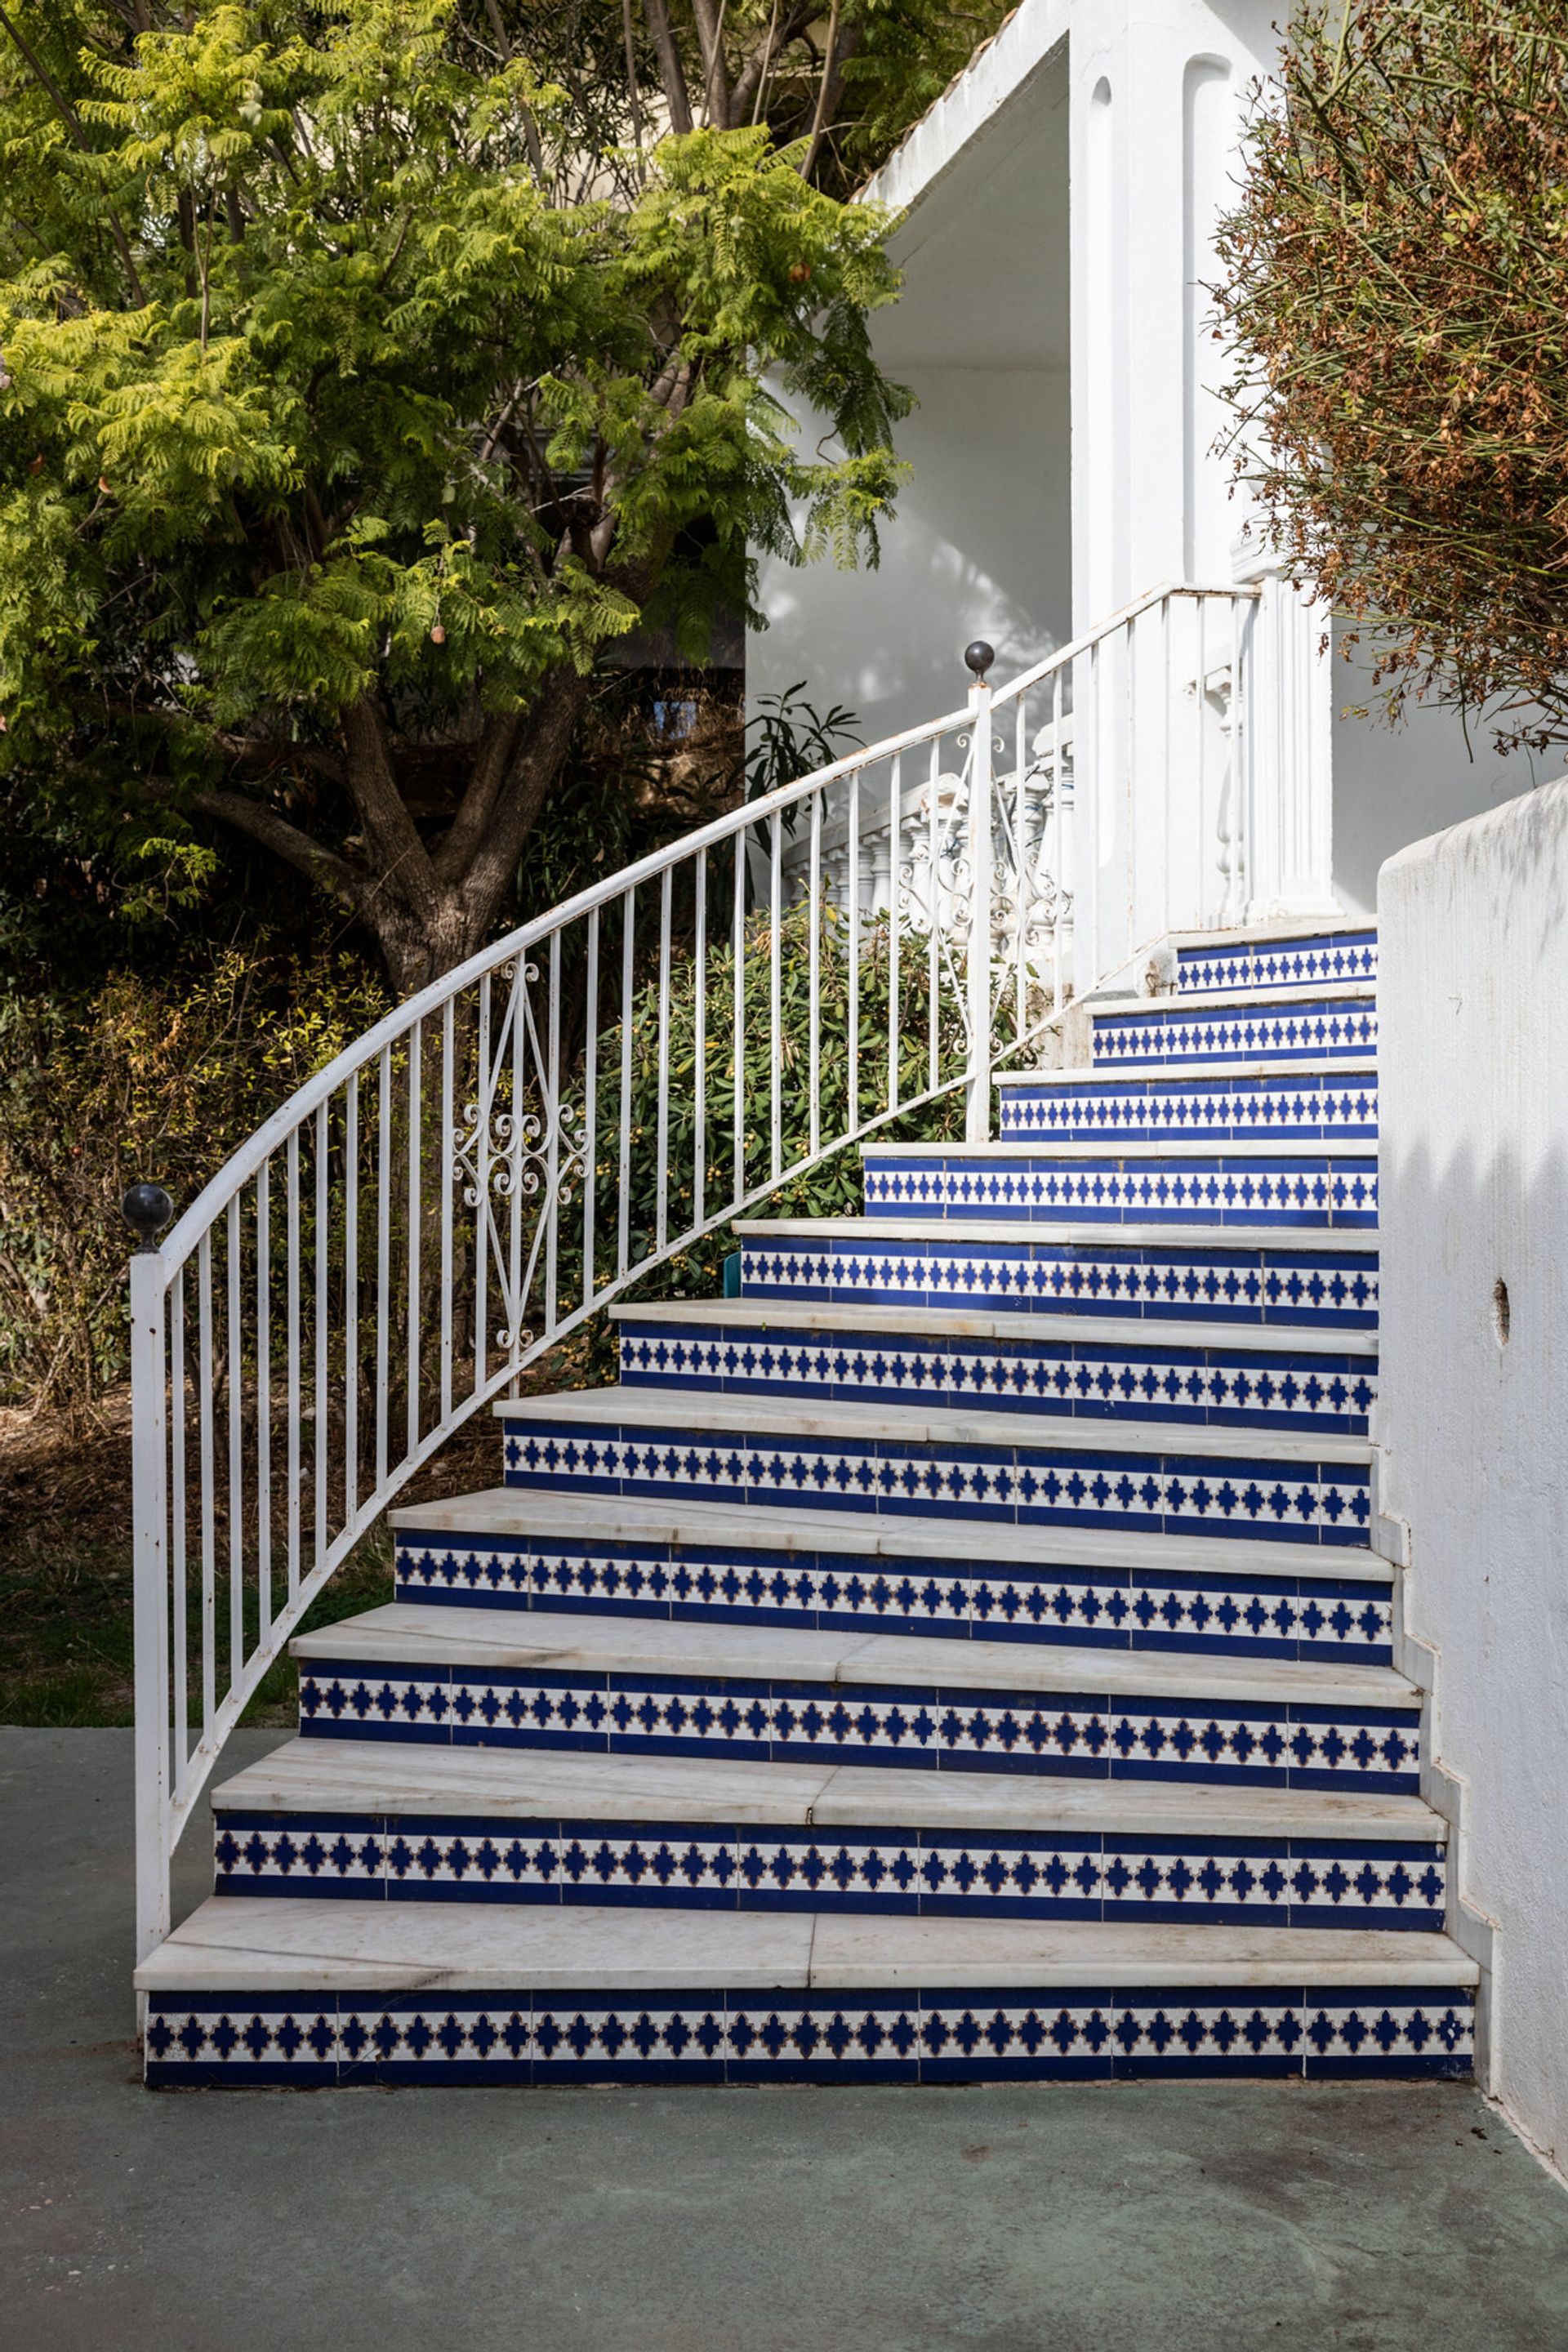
left=212, top=1740, right=1446, bottom=1933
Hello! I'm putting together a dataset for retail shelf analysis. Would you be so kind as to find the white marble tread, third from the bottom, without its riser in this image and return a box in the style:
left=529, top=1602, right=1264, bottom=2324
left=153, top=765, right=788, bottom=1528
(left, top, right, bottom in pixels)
left=289, top=1601, right=1420, bottom=1710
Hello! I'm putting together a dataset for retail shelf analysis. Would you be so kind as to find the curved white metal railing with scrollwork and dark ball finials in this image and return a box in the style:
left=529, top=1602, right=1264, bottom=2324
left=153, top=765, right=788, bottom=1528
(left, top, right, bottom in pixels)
left=127, top=588, right=1258, bottom=1957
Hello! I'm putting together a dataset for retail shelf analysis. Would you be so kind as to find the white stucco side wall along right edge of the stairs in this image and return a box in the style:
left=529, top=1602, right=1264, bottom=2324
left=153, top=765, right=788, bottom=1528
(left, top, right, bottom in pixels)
left=1373, top=781, right=1568, bottom=2166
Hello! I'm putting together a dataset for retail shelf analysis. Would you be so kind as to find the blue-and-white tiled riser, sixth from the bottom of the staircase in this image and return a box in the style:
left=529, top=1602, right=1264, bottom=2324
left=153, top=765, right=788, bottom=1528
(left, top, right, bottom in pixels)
left=621, top=1317, right=1378, bottom=1435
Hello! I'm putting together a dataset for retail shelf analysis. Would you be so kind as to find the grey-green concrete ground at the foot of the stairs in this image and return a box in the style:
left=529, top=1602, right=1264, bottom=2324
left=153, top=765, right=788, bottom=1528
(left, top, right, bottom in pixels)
left=0, top=1729, right=1568, bottom=2352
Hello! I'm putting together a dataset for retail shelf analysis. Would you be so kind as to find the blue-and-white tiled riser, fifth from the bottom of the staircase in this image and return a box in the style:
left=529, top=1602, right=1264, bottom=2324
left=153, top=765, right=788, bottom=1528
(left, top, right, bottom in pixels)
left=506, top=1419, right=1370, bottom=1545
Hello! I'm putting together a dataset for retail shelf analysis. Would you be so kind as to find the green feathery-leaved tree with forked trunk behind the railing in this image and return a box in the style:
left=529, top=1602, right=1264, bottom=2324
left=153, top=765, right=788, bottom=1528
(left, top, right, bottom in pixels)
left=0, top=0, right=985, bottom=990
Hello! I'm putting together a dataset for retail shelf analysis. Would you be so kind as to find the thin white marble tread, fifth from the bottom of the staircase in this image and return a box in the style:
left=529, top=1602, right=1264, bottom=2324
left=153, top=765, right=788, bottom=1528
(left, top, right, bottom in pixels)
left=492, top=1388, right=1373, bottom=1465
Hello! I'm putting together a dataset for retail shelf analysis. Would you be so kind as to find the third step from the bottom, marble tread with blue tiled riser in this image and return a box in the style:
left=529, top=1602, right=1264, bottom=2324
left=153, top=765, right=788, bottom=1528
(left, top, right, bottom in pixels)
left=292, top=1601, right=1420, bottom=1793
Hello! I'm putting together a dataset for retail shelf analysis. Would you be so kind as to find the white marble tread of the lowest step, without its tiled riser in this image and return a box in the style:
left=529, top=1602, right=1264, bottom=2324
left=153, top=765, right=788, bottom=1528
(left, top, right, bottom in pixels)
left=136, top=1895, right=1479, bottom=1997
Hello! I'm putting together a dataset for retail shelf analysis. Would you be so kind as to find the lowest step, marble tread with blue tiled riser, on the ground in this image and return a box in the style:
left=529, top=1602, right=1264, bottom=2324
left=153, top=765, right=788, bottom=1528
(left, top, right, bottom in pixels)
left=136, top=1895, right=1477, bottom=2087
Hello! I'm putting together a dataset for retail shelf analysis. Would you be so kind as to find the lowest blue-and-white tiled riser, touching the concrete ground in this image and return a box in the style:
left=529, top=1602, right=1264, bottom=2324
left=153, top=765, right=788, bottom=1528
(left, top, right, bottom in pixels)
left=145, top=1985, right=1474, bottom=2087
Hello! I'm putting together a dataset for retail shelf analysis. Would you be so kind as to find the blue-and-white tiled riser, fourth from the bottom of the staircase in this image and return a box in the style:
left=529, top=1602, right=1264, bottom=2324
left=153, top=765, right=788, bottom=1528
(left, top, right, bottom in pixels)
left=395, top=1529, right=1392, bottom=1665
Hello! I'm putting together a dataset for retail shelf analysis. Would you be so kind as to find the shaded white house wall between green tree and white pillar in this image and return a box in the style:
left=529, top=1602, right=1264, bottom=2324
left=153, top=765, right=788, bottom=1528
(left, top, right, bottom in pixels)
left=746, top=38, right=1072, bottom=743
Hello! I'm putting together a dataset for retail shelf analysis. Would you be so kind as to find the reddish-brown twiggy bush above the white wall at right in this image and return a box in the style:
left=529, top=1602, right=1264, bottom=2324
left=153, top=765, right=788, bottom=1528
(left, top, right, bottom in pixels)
left=1218, top=0, right=1568, bottom=746
